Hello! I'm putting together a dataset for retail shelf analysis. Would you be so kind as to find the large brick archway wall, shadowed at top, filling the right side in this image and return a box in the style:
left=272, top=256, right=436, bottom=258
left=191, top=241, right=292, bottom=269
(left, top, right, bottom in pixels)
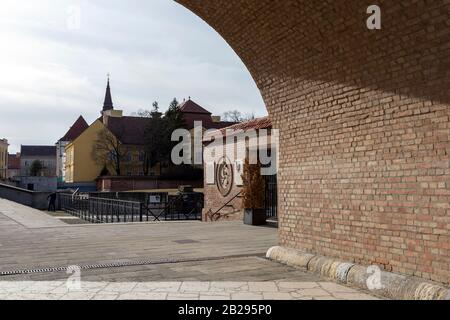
left=179, top=0, right=450, bottom=284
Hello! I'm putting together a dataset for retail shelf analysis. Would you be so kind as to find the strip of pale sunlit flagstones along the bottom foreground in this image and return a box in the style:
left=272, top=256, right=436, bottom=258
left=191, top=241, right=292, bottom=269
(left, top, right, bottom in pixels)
left=0, top=281, right=376, bottom=300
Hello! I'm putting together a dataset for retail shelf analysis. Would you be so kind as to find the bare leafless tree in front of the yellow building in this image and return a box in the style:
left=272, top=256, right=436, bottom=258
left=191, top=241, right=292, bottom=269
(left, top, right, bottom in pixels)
left=92, top=129, right=128, bottom=176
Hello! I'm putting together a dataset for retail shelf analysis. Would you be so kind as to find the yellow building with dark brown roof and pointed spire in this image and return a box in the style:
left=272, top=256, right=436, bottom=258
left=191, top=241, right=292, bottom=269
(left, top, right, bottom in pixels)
left=65, top=81, right=154, bottom=183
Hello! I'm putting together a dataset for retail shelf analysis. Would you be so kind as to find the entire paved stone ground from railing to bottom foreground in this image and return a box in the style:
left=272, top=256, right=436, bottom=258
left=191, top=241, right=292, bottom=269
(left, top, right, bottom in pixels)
left=0, top=199, right=380, bottom=299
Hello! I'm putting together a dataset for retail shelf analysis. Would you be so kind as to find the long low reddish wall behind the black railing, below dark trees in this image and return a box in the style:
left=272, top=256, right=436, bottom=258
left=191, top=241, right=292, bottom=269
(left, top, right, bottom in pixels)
left=97, top=177, right=203, bottom=192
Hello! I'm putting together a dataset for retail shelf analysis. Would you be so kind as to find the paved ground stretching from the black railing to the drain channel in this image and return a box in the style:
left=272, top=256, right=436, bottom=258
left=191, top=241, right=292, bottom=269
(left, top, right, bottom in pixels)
left=0, top=200, right=277, bottom=272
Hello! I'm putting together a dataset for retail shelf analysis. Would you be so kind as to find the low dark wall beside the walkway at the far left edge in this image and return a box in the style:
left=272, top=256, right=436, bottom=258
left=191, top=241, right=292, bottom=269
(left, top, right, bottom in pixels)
left=0, top=184, right=50, bottom=210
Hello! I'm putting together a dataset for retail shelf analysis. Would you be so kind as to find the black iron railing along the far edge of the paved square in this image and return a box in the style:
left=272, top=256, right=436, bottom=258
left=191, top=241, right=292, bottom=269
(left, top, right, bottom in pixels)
left=59, top=193, right=203, bottom=223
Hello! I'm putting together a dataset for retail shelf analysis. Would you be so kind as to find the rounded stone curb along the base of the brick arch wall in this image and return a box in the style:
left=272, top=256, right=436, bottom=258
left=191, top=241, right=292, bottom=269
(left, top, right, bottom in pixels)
left=266, top=246, right=450, bottom=300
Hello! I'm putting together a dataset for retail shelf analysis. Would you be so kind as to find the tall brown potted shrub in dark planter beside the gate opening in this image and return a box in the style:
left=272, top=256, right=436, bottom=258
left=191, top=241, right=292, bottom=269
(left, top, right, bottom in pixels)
left=242, top=159, right=267, bottom=226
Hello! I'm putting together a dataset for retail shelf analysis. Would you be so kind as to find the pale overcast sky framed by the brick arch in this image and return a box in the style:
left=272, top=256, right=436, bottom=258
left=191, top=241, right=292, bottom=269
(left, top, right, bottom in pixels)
left=0, top=0, right=266, bottom=152
